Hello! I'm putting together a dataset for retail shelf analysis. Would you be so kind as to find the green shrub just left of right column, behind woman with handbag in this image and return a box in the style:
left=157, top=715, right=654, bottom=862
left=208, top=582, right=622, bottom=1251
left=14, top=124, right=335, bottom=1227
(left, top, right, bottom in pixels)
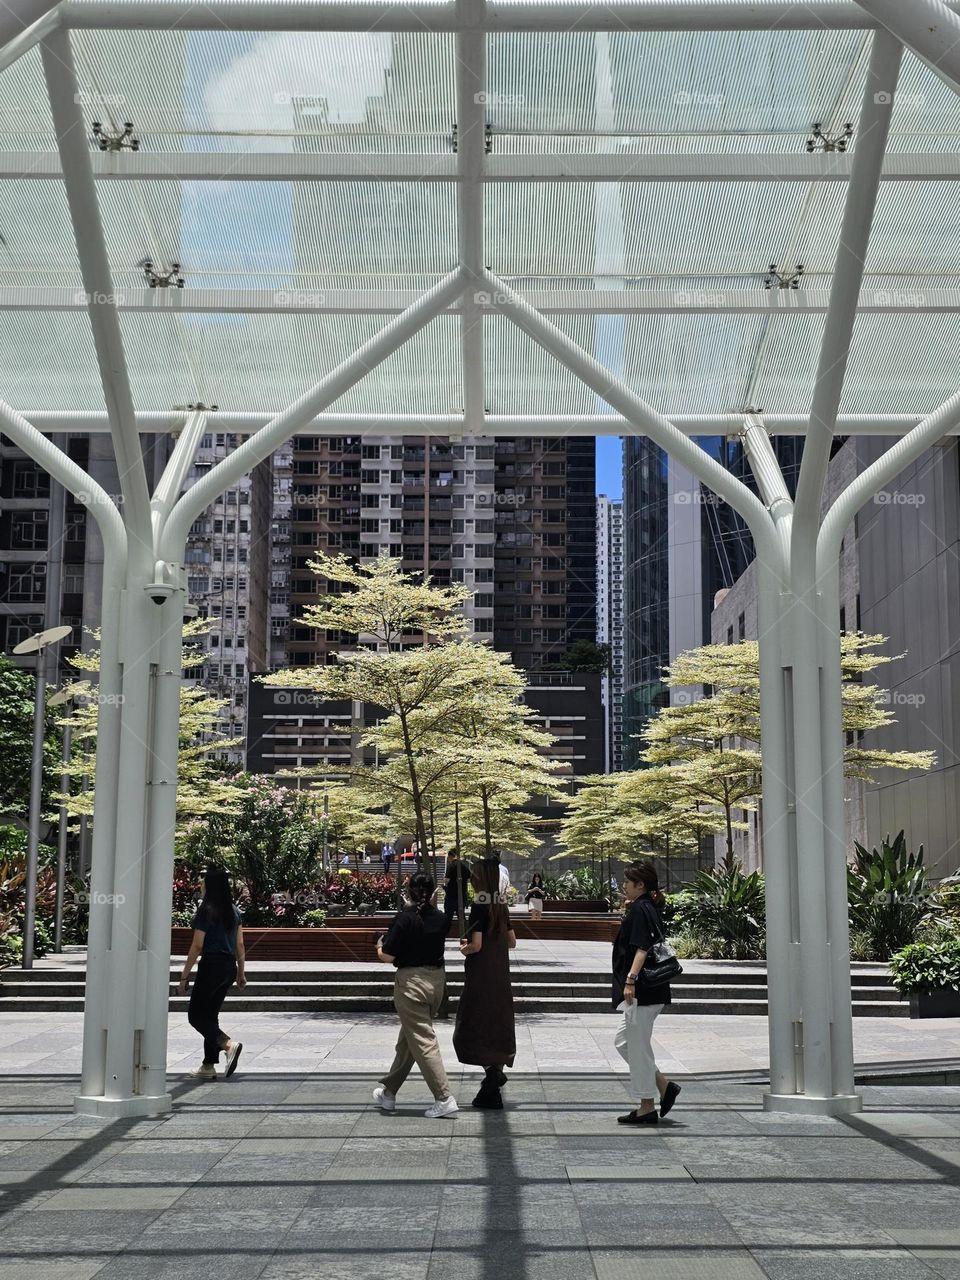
left=672, top=864, right=767, bottom=960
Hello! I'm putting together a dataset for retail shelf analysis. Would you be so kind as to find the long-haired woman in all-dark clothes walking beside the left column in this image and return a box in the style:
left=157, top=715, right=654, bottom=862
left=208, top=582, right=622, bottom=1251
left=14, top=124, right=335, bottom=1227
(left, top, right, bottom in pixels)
left=178, top=868, right=247, bottom=1080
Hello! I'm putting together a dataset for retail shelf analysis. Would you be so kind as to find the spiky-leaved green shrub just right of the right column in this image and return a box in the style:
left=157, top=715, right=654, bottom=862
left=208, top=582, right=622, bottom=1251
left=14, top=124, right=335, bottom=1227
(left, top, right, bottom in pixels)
left=847, top=831, right=936, bottom=960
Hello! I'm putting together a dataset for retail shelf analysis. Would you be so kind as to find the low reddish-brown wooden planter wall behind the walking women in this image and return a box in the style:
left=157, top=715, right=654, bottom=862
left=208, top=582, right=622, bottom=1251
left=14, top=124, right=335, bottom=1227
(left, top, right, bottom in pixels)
left=170, top=914, right=620, bottom=964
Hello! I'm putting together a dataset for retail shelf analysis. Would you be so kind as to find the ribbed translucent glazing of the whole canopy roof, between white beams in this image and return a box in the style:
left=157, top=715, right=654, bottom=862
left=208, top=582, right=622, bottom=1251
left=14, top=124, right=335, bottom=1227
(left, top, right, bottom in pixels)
left=0, top=21, right=960, bottom=413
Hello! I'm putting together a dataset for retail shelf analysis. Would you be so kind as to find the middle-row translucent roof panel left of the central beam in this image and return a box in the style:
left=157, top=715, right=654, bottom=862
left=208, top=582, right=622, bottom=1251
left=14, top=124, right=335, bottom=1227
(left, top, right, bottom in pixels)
left=0, top=182, right=457, bottom=291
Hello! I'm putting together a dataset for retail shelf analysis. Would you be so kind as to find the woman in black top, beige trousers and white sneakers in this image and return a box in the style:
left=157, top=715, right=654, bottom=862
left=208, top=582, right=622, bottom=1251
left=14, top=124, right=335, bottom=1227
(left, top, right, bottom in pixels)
left=374, top=872, right=458, bottom=1120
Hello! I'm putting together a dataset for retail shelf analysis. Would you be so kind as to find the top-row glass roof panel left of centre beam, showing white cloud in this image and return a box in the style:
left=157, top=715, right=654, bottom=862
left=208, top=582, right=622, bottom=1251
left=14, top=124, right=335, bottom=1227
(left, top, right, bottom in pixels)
left=68, top=31, right=454, bottom=151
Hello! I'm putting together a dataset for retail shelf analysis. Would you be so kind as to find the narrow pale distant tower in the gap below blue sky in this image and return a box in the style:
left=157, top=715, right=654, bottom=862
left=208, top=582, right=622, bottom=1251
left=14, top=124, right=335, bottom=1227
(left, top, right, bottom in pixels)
left=596, top=494, right=623, bottom=773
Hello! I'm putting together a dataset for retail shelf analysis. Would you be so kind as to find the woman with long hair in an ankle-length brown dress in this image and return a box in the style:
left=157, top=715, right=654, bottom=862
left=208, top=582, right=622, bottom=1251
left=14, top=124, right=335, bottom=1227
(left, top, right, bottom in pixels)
left=453, top=858, right=517, bottom=1111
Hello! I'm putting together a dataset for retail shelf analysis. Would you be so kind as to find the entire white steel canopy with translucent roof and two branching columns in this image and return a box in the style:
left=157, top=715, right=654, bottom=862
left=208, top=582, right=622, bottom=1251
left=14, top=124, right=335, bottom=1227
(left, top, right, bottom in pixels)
left=0, top=0, right=960, bottom=1115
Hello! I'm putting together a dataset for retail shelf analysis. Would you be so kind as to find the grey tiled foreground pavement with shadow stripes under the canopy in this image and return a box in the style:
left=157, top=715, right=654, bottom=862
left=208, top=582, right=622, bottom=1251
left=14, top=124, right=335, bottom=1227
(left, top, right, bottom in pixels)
left=0, top=1071, right=960, bottom=1280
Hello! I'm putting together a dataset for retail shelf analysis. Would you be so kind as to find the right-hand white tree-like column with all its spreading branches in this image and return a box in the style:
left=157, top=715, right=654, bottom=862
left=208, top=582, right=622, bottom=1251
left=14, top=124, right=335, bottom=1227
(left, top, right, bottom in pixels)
left=486, top=31, right=960, bottom=1114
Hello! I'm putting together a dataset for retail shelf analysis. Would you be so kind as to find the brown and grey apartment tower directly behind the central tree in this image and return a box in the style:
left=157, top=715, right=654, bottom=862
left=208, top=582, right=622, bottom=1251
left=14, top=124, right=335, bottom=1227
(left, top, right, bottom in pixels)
left=288, top=435, right=596, bottom=669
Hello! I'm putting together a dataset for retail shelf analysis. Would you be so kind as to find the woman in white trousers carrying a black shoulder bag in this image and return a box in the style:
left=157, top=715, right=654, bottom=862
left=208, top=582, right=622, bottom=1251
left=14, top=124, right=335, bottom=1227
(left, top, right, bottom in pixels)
left=613, top=861, right=680, bottom=1124
